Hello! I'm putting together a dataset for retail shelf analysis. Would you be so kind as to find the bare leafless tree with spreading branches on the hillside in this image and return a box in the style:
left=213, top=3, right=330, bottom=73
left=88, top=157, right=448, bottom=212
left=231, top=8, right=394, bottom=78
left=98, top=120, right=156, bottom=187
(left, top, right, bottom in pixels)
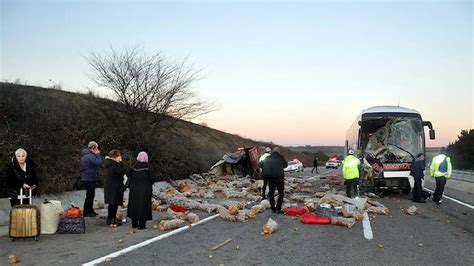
left=86, top=47, right=213, bottom=149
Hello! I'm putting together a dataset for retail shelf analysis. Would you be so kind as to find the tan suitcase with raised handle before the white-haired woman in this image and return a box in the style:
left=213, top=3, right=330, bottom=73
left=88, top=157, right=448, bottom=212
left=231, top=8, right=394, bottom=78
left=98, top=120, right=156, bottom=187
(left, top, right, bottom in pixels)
left=8, top=188, right=41, bottom=241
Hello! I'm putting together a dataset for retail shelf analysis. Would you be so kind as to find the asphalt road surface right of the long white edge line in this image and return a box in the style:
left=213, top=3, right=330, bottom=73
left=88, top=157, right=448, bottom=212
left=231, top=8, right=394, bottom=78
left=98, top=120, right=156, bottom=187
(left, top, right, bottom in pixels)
left=97, top=169, right=474, bottom=265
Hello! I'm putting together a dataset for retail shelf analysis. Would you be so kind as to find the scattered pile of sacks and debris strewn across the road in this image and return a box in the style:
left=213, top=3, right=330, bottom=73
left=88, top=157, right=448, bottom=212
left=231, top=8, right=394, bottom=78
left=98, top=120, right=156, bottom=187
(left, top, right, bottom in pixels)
left=152, top=174, right=389, bottom=231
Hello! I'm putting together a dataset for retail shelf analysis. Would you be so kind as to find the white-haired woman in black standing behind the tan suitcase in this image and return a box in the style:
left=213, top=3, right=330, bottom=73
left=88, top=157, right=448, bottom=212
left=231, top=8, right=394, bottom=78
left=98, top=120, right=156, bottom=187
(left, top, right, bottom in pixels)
left=6, top=148, right=38, bottom=207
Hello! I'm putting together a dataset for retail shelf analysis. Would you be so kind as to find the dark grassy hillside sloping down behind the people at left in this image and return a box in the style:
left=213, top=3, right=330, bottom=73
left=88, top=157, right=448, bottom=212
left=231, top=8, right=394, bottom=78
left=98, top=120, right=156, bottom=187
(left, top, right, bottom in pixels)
left=0, top=83, right=311, bottom=193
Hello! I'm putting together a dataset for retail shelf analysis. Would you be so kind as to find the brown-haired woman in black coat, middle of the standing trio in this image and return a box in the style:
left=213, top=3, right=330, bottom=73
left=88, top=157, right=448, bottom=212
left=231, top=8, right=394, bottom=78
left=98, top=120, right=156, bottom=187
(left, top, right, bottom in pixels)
left=104, top=150, right=127, bottom=225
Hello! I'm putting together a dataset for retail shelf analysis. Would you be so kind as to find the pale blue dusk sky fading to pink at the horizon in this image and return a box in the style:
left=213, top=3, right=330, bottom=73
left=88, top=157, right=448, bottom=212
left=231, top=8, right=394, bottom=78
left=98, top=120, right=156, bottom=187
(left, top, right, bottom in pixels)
left=0, top=0, right=474, bottom=146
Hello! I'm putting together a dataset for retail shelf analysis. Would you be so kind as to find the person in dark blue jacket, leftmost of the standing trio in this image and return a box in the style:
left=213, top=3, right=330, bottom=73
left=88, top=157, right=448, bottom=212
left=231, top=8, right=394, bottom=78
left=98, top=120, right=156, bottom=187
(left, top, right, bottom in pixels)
left=81, top=141, right=103, bottom=217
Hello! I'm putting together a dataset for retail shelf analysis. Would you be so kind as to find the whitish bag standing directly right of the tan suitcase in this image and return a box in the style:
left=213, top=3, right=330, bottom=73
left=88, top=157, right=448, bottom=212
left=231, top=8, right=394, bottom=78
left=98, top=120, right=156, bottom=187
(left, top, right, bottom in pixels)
left=40, top=200, right=64, bottom=235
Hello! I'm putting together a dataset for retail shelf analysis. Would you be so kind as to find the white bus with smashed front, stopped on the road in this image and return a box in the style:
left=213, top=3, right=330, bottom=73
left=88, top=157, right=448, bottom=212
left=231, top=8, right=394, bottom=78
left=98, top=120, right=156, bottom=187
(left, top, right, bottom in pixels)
left=345, top=106, right=435, bottom=193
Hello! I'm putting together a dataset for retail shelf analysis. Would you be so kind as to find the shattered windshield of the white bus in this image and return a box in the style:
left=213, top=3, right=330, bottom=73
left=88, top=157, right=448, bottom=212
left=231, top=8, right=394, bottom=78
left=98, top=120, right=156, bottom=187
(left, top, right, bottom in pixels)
left=361, top=117, right=423, bottom=163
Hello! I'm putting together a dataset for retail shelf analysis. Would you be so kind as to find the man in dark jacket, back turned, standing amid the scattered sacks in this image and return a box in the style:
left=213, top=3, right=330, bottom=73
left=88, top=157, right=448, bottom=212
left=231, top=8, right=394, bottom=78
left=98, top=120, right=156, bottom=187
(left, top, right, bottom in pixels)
left=260, top=147, right=288, bottom=213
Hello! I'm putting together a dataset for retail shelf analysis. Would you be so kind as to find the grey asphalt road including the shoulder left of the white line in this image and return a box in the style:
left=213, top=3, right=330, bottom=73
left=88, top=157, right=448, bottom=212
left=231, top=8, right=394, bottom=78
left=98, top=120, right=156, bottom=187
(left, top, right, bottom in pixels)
left=0, top=168, right=474, bottom=265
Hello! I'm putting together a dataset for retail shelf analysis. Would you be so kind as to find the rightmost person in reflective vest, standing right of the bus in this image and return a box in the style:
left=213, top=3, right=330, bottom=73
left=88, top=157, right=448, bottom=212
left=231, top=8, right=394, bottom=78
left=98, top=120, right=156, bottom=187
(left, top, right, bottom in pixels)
left=430, top=148, right=452, bottom=205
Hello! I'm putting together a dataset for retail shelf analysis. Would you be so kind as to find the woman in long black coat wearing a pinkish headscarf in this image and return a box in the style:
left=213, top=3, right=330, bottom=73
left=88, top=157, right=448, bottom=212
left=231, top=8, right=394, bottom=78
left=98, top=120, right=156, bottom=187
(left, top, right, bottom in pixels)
left=127, top=151, right=155, bottom=229
